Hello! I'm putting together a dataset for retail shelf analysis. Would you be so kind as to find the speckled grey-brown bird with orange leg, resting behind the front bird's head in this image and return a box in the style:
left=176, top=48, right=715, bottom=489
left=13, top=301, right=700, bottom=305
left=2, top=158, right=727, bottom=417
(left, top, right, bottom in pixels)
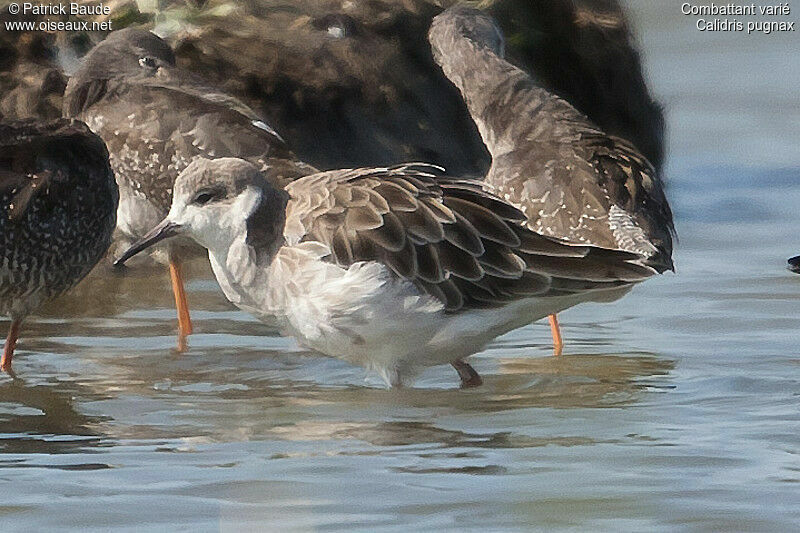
left=64, top=29, right=315, bottom=349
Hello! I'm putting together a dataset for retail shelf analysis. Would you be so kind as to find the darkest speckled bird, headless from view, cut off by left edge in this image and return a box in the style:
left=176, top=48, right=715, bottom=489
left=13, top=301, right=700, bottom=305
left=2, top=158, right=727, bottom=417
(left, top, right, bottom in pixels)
left=0, top=119, right=119, bottom=370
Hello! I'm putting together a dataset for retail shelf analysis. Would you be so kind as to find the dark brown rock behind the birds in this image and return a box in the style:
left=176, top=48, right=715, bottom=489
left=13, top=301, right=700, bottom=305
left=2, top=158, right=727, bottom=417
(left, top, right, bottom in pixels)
left=0, top=0, right=664, bottom=174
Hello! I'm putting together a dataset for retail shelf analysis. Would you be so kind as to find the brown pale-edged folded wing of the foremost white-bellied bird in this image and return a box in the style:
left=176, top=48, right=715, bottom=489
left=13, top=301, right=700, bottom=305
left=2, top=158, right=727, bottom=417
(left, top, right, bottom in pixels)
left=287, top=165, right=655, bottom=312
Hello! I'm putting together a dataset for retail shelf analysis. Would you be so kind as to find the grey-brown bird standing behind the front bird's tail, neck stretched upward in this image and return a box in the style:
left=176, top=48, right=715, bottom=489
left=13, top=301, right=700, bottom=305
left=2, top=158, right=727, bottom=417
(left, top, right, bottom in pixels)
left=429, top=6, right=674, bottom=354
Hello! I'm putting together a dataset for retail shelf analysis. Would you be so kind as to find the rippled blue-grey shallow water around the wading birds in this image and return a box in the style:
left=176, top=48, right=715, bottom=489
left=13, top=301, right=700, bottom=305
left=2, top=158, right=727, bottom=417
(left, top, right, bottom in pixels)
left=0, top=2, right=800, bottom=531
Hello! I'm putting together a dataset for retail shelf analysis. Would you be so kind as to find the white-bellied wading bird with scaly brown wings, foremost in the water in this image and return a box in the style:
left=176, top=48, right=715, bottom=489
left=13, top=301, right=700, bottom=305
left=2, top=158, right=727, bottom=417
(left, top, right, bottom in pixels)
left=115, top=158, right=656, bottom=386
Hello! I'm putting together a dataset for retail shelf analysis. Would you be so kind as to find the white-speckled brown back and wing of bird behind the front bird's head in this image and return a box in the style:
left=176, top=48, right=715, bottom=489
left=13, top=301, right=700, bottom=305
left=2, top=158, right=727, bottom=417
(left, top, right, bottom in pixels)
left=64, top=68, right=316, bottom=221
